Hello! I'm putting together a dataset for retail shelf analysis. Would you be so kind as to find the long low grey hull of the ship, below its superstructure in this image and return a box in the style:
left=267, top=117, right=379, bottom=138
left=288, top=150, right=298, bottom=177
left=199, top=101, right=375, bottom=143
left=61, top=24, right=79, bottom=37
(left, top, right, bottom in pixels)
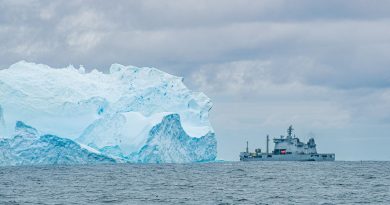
left=240, top=152, right=335, bottom=161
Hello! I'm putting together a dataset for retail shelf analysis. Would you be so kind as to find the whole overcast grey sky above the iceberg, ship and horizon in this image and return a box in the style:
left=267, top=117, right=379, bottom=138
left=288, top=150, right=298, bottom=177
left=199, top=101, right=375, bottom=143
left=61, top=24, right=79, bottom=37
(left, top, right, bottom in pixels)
left=0, top=0, right=390, bottom=160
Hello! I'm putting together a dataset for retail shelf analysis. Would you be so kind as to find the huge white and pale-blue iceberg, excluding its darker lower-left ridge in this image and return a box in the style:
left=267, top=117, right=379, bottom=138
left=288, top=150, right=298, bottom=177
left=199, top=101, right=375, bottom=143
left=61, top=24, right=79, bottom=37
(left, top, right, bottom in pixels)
left=0, top=61, right=216, bottom=164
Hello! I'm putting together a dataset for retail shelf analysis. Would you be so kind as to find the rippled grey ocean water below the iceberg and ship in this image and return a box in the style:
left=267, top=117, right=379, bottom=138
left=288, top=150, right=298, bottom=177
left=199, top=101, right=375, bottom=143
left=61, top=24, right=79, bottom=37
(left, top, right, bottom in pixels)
left=0, top=161, right=390, bottom=205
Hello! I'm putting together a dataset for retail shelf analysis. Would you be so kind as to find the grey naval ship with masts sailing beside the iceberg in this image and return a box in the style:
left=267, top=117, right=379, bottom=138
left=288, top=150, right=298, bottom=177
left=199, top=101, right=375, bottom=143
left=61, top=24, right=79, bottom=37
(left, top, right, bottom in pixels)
left=240, top=125, right=335, bottom=161
